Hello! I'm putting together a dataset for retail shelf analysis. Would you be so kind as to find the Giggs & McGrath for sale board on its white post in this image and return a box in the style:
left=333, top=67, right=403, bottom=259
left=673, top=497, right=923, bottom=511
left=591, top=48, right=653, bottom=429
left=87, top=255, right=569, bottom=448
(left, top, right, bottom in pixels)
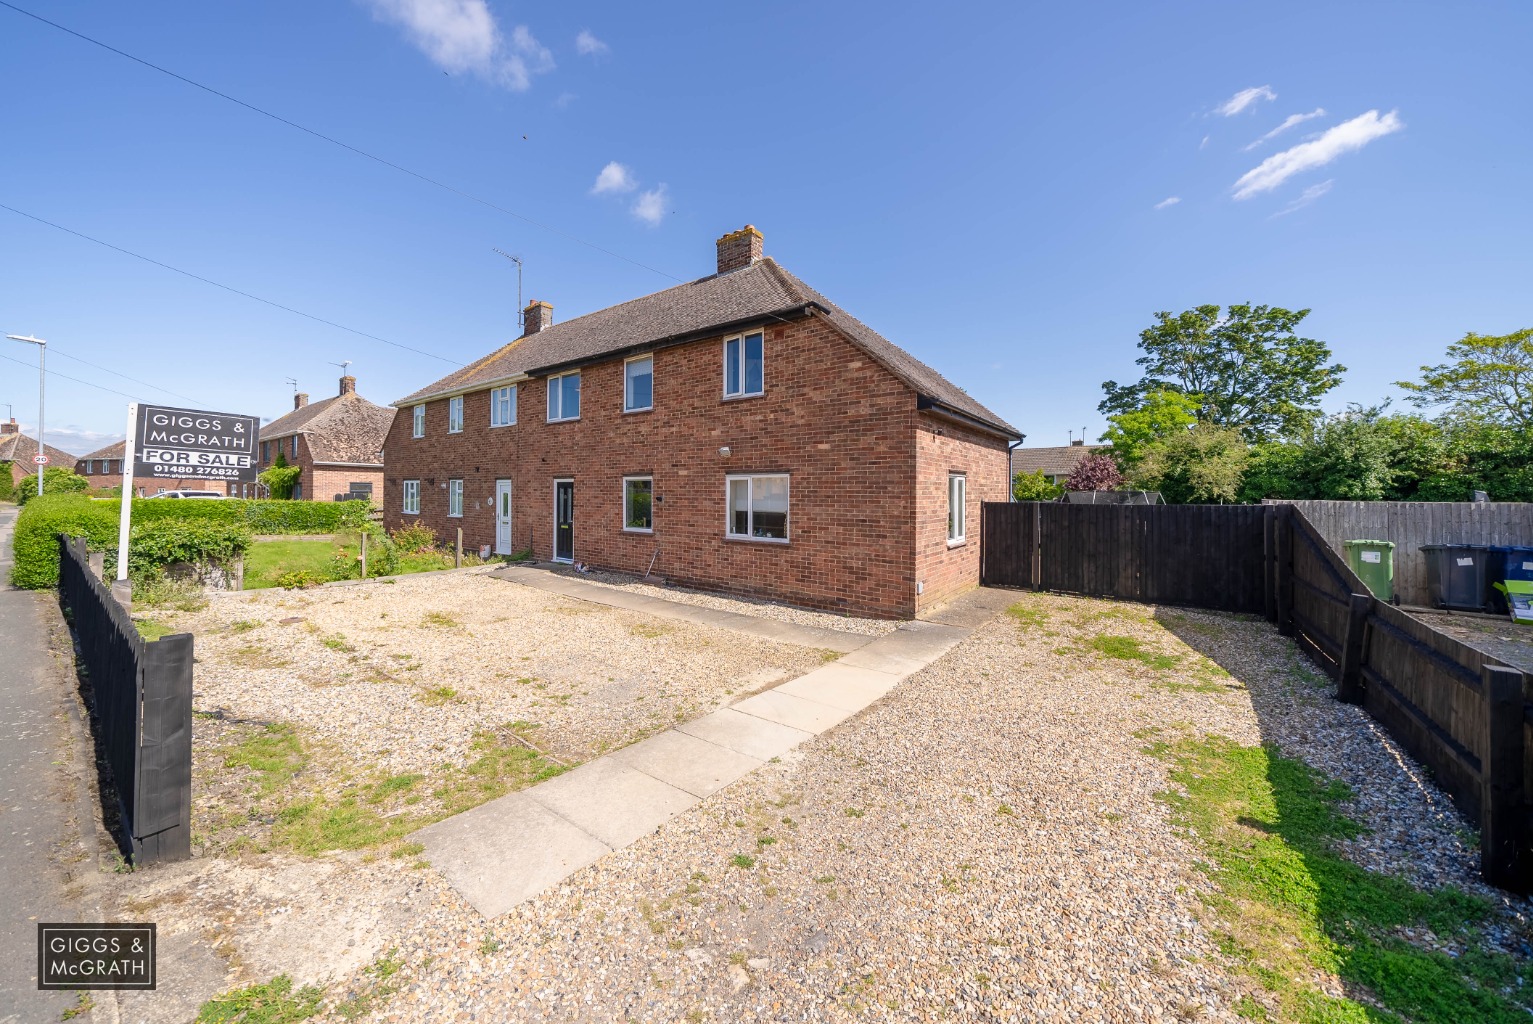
left=112, top=402, right=261, bottom=607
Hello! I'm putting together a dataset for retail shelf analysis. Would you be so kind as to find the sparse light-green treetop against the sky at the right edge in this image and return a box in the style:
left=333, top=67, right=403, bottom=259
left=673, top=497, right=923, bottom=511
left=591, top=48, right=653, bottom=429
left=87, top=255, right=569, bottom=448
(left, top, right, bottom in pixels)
left=1398, top=327, right=1533, bottom=431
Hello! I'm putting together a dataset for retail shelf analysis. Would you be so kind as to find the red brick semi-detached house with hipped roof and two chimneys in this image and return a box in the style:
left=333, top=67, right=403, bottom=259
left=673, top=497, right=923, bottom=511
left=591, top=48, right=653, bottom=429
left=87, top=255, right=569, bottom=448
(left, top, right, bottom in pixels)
left=383, top=227, right=1019, bottom=618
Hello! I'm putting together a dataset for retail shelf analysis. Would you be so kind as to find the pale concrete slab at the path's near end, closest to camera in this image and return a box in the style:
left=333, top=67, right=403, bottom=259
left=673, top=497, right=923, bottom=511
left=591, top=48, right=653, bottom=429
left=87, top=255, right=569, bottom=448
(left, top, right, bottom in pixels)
left=414, top=793, right=612, bottom=917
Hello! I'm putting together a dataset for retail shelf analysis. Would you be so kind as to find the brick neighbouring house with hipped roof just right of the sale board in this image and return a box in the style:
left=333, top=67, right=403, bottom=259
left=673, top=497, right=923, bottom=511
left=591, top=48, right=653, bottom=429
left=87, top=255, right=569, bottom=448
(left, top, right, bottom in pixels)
left=257, top=374, right=394, bottom=501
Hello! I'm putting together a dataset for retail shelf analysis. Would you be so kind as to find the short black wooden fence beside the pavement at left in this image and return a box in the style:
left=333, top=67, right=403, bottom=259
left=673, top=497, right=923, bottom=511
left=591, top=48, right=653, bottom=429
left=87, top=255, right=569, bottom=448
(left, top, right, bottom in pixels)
left=58, top=537, right=192, bottom=865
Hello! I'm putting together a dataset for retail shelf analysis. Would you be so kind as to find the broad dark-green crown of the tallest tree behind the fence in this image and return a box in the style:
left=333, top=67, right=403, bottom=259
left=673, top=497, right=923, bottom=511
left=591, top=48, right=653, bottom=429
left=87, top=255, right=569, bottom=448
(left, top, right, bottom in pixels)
left=1098, top=304, right=1346, bottom=441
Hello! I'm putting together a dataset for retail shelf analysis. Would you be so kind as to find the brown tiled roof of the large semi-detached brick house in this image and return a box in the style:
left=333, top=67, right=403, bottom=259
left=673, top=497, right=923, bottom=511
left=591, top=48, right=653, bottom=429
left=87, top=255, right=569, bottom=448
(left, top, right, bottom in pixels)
left=394, top=258, right=1018, bottom=437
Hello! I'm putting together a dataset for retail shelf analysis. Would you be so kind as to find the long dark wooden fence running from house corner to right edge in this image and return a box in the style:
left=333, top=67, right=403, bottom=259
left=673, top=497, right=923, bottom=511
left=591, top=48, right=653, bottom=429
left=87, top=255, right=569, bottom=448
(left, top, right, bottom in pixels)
left=980, top=501, right=1533, bottom=892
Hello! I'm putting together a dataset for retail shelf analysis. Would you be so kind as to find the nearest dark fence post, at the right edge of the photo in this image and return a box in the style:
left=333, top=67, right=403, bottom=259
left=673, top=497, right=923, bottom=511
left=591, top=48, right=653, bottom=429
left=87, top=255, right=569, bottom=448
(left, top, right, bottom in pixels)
left=1479, top=665, right=1528, bottom=892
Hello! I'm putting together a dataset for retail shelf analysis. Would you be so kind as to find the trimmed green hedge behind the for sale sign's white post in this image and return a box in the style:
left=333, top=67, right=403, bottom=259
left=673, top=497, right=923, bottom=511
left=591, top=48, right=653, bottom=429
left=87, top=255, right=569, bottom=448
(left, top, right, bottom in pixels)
left=11, top=494, right=369, bottom=590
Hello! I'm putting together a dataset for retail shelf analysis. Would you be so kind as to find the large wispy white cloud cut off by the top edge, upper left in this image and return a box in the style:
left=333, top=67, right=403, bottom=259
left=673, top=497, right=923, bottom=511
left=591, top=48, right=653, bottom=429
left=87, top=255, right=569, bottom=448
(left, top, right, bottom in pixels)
left=363, top=0, right=553, bottom=92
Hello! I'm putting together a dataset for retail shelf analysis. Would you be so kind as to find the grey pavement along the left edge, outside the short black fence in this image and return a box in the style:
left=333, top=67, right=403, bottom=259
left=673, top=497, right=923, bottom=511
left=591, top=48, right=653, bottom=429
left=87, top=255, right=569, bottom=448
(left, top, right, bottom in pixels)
left=0, top=506, right=101, bottom=1024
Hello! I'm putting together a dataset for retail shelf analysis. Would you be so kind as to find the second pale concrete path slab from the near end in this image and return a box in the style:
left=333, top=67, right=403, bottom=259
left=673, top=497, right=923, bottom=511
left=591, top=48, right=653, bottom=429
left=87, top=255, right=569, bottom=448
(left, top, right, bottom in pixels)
left=526, top=757, right=698, bottom=849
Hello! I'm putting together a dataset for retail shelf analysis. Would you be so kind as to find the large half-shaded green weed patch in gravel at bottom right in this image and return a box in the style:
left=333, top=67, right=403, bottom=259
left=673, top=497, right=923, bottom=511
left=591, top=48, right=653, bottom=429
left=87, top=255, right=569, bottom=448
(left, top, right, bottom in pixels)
left=1150, top=737, right=1533, bottom=1024
